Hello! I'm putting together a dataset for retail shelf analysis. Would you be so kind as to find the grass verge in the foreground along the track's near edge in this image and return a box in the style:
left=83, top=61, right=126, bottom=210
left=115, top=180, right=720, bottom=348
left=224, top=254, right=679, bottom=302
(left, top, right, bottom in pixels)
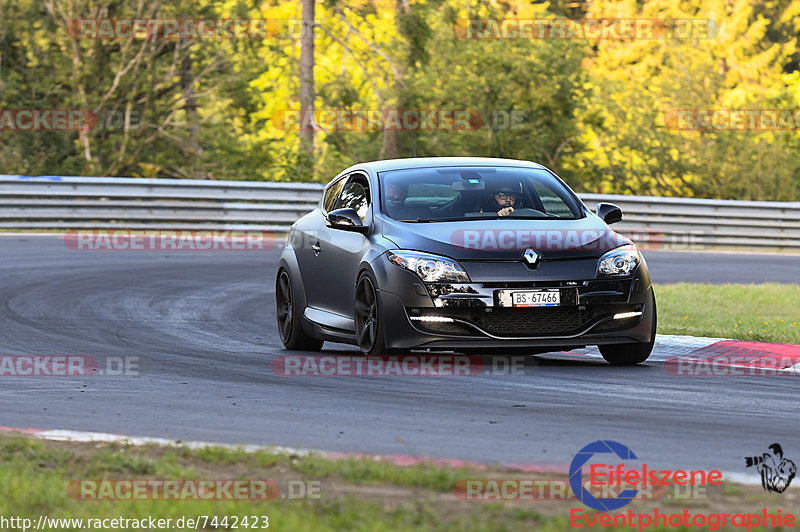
left=0, top=435, right=779, bottom=532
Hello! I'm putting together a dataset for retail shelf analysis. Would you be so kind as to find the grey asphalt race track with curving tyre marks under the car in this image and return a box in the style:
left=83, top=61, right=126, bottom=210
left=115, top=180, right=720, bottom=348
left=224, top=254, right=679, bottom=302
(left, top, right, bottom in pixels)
left=0, top=235, right=800, bottom=471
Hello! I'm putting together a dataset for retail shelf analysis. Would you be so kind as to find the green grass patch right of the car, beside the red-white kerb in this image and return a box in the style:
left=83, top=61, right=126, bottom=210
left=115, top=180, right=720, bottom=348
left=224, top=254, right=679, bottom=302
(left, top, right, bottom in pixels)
left=655, top=283, right=800, bottom=344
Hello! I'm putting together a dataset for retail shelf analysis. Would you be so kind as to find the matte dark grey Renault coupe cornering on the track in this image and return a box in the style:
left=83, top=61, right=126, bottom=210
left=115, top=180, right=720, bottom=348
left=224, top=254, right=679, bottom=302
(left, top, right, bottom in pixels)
left=275, top=157, right=656, bottom=364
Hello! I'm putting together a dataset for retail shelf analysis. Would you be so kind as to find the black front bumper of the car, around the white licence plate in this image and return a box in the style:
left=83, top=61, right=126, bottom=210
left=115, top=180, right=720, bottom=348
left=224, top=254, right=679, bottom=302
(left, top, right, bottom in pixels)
left=372, top=256, right=655, bottom=351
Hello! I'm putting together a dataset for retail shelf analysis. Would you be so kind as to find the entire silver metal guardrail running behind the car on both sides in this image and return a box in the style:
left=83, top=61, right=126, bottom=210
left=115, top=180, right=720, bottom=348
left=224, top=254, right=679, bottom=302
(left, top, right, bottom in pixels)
left=0, top=175, right=800, bottom=250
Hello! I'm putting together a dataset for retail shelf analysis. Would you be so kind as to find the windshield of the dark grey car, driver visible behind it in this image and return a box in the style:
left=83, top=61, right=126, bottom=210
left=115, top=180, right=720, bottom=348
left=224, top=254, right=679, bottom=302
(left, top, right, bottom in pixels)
left=379, top=167, right=584, bottom=223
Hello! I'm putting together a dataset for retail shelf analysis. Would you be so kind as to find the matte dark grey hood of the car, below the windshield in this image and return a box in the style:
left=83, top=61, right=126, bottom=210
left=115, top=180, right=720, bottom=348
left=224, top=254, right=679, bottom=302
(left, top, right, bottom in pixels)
left=383, top=216, right=632, bottom=261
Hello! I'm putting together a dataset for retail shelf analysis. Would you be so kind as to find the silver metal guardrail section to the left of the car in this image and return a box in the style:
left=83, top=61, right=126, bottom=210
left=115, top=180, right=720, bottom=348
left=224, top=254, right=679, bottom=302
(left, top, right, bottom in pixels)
left=0, top=175, right=323, bottom=231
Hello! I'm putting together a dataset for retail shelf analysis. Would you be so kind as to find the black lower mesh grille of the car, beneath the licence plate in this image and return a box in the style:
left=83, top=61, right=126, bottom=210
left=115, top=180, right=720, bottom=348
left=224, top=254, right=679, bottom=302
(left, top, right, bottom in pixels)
left=410, top=305, right=630, bottom=337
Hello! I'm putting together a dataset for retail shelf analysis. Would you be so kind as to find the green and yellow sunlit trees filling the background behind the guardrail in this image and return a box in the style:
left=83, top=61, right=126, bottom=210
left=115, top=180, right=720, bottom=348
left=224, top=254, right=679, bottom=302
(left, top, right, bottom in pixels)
left=0, top=0, right=800, bottom=200
